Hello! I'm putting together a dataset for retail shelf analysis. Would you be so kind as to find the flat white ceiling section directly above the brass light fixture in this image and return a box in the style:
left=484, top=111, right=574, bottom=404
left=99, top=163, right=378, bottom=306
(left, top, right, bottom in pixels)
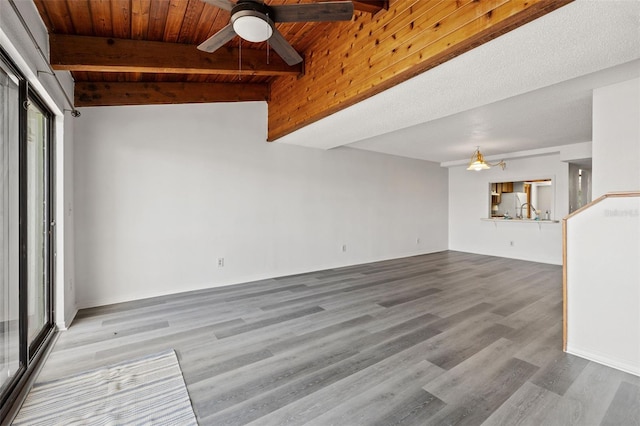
left=347, top=60, right=640, bottom=162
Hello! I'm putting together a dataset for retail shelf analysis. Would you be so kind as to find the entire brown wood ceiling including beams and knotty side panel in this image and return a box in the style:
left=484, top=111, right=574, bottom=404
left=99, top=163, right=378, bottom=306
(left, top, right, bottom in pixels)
left=34, top=0, right=572, bottom=140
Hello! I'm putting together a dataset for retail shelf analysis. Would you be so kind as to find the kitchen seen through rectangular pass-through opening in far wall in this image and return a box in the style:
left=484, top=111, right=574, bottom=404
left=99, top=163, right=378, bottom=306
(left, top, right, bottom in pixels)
left=489, top=178, right=554, bottom=221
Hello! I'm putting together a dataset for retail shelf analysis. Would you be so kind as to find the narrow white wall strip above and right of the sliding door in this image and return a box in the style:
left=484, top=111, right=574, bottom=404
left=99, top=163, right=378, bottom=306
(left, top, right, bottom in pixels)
left=0, top=0, right=77, bottom=328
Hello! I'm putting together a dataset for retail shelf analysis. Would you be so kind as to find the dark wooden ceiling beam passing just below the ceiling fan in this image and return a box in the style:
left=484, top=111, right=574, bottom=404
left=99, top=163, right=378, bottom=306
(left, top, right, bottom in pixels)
left=49, top=34, right=303, bottom=76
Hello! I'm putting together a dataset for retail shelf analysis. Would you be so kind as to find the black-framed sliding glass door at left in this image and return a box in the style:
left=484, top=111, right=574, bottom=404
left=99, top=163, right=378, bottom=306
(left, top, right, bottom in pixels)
left=0, top=50, right=54, bottom=424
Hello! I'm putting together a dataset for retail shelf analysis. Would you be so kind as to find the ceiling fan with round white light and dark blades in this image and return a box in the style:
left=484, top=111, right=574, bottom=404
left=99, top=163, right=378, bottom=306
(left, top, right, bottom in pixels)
left=198, top=0, right=353, bottom=65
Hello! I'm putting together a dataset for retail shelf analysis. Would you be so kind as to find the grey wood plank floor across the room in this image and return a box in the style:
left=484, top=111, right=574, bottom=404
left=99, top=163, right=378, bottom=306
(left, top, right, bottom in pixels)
left=38, top=251, right=640, bottom=426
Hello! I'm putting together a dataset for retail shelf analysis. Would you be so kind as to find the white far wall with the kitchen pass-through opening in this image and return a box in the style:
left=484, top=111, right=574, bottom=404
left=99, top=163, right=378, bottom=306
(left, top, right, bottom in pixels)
left=449, top=148, right=569, bottom=265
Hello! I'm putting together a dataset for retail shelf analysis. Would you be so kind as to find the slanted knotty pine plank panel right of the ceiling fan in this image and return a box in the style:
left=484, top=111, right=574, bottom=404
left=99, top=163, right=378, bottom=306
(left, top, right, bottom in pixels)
left=268, top=0, right=572, bottom=141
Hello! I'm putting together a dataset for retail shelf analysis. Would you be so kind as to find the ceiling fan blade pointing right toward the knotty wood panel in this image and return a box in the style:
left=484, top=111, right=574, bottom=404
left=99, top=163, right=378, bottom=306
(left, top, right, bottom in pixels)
left=270, top=1, right=353, bottom=22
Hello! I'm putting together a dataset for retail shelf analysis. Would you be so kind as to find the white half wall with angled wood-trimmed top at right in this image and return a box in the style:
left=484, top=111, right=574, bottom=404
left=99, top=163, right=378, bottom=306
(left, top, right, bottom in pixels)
left=567, top=197, right=640, bottom=375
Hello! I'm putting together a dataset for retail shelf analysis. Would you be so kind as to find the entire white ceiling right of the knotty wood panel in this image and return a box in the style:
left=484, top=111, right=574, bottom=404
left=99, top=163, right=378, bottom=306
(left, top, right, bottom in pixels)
left=277, top=0, right=640, bottom=162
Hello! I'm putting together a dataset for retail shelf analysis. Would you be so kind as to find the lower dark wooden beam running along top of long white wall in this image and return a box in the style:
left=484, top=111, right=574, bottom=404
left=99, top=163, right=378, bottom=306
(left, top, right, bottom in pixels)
left=75, top=82, right=269, bottom=107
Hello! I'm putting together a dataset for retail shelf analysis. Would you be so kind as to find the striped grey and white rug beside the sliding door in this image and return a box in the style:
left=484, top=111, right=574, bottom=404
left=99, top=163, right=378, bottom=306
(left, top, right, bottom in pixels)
left=13, top=350, right=198, bottom=426
